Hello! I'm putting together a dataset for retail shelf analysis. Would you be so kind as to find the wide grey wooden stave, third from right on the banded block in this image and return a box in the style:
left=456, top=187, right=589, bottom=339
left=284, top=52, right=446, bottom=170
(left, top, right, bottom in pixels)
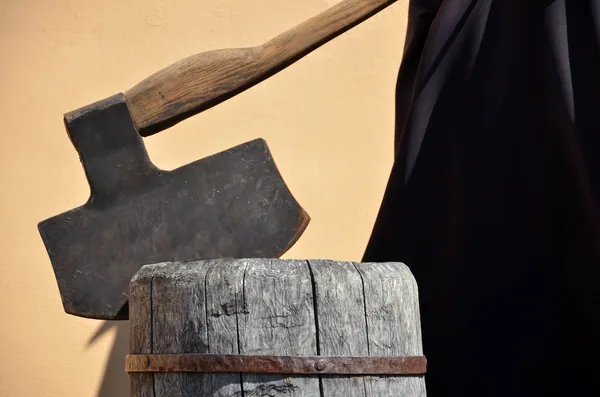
left=238, top=259, right=319, bottom=397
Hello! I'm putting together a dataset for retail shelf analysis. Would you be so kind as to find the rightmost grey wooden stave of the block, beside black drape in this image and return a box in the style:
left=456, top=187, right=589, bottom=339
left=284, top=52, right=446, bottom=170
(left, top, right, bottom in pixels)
left=355, top=262, right=426, bottom=397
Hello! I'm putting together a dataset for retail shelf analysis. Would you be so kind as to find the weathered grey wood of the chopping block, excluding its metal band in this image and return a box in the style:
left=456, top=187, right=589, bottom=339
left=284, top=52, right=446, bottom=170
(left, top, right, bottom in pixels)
left=130, top=259, right=426, bottom=397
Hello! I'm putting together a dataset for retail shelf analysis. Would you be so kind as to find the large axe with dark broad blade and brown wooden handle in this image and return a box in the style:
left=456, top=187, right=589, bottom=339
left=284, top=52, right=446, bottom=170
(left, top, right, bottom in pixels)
left=38, top=0, right=395, bottom=320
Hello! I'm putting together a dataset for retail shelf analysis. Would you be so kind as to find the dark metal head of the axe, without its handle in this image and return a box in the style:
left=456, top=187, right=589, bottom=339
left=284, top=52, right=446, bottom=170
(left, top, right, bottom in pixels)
left=38, top=94, right=310, bottom=320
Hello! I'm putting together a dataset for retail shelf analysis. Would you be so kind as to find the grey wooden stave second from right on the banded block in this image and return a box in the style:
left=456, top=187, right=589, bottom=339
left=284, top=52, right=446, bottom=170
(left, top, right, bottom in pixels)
left=309, top=260, right=369, bottom=397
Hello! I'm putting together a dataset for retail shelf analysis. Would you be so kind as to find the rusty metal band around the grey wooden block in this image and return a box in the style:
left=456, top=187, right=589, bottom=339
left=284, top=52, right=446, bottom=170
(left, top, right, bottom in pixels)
left=125, top=353, right=427, bottom=375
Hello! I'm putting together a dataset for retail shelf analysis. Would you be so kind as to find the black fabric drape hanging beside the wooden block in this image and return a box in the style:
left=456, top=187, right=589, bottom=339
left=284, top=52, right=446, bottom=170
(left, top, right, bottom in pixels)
left=363, top=0, right=600, bottom=397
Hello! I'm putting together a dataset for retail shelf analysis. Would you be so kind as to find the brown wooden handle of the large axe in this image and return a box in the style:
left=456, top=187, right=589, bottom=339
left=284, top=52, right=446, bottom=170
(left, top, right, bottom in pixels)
left=125, top=0, right=397, bottom=136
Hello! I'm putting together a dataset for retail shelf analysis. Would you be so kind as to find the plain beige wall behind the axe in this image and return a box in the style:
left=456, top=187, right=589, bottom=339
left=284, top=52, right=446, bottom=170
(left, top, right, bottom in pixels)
left=0, top=0, right=407, bottom=397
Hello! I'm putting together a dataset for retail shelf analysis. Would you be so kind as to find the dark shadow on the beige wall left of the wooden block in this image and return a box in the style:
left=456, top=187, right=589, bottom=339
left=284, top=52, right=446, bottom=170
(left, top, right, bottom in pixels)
left=88, top=321, right=129, bottom=397
